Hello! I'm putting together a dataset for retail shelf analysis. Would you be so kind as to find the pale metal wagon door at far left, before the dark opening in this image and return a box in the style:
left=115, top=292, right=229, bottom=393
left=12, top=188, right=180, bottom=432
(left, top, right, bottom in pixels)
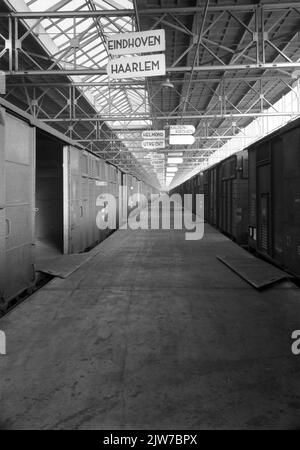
left=1, top=113, right=35, bottom=302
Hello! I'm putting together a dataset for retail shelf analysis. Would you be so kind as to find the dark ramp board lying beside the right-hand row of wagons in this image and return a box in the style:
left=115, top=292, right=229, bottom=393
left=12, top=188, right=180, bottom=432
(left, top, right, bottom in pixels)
left=217, top=250, right=291, bottom=289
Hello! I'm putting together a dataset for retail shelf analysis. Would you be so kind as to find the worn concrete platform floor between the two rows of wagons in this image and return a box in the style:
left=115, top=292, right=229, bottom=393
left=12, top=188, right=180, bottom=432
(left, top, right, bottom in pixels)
left=0, top=204, right=300, bottom=430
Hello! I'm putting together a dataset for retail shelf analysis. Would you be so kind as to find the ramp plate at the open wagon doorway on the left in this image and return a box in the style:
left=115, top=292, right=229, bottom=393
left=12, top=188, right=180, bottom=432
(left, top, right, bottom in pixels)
left=36, top=253, right=92, bottom=278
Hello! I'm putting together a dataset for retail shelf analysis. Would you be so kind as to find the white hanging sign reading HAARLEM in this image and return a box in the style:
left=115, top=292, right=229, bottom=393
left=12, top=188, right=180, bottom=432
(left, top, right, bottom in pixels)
left=106, top=54, right=166, bottom=79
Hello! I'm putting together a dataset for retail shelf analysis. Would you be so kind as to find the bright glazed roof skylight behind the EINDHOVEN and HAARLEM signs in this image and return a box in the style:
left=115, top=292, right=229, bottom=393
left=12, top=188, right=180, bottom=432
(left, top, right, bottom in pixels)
left=24, top=0, right=151, bottom=129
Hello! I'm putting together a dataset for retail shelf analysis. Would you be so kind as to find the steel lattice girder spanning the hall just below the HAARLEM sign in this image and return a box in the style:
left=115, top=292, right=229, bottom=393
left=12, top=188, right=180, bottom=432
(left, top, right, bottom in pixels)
left=6, top=78, right=300, bottom=120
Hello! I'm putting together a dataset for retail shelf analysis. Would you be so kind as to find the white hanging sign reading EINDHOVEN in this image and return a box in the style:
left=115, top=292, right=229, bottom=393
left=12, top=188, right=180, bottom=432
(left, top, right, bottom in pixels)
left=107, top=30, right=166, bottom=56
